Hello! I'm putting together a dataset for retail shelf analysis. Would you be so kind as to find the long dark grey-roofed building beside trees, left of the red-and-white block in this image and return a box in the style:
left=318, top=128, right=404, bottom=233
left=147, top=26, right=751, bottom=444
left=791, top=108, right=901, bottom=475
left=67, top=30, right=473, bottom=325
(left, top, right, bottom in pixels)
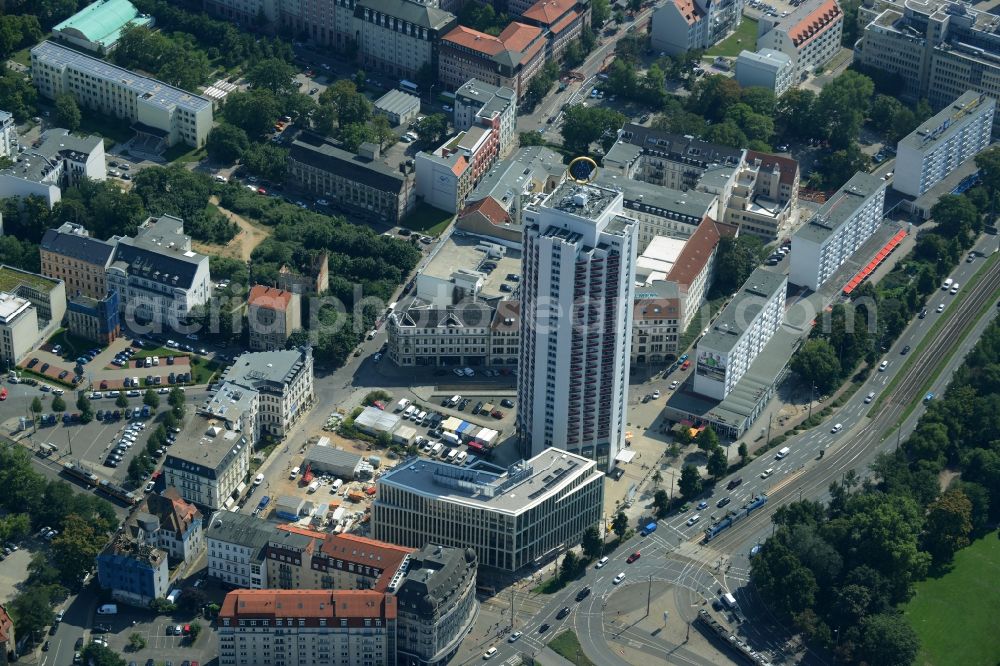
left=286, top=132, right=417, bottom=225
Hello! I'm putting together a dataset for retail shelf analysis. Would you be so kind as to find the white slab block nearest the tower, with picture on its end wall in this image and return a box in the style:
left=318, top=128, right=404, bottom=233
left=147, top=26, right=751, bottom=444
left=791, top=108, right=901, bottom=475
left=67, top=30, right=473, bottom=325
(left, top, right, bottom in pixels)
left=694, top=268, right=788, bottom=400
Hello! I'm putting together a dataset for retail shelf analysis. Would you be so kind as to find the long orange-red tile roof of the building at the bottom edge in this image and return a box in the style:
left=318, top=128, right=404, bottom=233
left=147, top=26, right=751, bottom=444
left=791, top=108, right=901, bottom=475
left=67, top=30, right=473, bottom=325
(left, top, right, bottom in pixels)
left=219, top=590, right=396, bottom=626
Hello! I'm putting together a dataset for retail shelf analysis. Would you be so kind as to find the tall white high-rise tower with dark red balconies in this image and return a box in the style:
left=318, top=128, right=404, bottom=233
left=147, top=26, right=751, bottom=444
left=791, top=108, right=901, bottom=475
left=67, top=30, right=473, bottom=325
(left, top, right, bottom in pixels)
left=517, top=181, right=639, bottom=470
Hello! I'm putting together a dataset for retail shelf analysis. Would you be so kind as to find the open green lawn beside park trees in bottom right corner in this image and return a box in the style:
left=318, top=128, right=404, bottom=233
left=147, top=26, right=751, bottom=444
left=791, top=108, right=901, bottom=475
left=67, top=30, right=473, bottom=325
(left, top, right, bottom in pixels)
left=903, top=532, right=1000, bottom=666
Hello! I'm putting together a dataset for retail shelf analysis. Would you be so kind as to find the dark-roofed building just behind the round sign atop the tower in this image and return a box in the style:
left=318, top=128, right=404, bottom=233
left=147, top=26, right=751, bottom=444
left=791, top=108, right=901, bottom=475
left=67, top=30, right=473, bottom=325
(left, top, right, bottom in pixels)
left=609, top=123, right=743, bottom=190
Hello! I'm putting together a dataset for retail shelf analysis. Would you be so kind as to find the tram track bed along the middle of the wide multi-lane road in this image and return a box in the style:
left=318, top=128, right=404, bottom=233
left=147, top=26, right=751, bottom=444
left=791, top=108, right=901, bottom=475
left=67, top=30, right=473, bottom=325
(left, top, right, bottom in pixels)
left=698, top=261, right=1000, bottom=553
